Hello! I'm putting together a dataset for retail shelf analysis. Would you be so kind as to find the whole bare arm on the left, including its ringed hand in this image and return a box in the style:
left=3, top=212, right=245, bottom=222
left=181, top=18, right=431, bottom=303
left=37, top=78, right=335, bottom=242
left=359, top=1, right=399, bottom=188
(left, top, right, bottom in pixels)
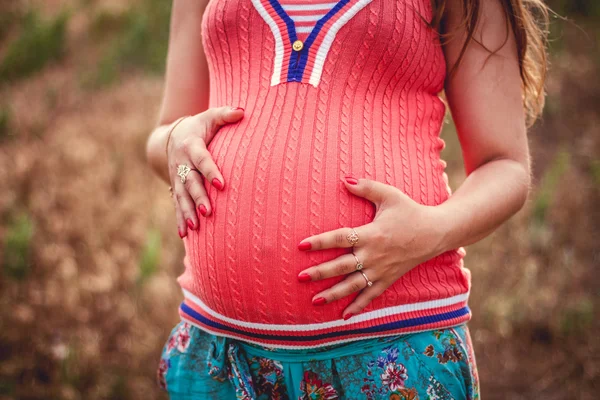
left=146, top=0, right=244, bottom=238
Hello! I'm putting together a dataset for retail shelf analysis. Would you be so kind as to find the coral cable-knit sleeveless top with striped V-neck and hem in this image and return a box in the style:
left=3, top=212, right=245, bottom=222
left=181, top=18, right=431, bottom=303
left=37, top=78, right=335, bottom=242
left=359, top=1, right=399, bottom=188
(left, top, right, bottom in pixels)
left=178, top=0, right=471, bottom=348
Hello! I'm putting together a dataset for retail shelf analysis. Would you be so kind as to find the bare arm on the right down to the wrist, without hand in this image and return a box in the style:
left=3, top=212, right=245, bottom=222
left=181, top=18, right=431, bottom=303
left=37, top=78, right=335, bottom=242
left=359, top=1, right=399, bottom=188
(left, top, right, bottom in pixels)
left=438, top=0, right=530, bottom=251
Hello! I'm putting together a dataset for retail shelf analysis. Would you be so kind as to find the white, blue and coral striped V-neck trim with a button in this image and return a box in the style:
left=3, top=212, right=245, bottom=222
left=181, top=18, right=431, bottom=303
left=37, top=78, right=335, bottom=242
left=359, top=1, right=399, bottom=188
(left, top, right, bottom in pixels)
left=252, top=0, right=372, bottom=87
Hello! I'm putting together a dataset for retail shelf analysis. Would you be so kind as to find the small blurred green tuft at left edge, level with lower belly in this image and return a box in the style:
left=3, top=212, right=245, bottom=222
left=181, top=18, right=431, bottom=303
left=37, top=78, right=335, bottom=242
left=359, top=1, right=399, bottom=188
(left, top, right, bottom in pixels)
left=4, top=213, right=33, bottom=280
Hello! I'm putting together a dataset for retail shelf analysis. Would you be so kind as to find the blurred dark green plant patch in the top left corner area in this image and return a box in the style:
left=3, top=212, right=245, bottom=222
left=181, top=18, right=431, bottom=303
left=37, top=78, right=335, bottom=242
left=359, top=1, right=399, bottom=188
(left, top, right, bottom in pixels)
left=0, top=11, right=69, bottom=82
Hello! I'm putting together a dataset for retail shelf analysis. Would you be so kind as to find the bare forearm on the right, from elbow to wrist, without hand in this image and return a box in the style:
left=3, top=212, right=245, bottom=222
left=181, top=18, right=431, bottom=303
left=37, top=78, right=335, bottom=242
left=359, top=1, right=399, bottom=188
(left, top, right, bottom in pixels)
left=437, top=159, right=530, bottom=252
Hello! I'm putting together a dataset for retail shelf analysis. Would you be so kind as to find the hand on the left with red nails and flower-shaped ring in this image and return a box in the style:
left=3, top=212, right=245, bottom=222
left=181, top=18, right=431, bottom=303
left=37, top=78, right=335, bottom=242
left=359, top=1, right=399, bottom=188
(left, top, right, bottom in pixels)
left=167, top=106, right=244, bottom=238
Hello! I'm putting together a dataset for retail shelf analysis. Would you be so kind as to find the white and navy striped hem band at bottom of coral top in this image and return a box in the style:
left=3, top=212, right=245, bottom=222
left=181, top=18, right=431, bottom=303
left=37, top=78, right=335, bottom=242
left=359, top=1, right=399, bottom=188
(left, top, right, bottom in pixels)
left=179, top=289, right=471, bottom=349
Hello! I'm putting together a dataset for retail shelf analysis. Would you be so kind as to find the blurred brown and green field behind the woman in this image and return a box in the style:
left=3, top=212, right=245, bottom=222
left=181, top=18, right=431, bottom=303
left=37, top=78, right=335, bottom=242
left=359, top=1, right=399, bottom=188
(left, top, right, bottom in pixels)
left=0, top=0, right=600, bottom=400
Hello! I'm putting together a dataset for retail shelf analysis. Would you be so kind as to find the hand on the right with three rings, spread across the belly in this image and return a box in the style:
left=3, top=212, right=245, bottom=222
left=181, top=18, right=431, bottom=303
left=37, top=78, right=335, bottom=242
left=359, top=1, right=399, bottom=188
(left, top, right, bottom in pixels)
left=298, top=177, right=444, bottom=319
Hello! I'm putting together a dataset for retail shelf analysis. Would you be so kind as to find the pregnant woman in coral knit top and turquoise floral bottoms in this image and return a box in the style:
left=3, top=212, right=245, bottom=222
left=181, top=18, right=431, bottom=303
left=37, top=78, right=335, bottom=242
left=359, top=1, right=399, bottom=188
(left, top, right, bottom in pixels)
left=147, top=0, right=546, bottom=399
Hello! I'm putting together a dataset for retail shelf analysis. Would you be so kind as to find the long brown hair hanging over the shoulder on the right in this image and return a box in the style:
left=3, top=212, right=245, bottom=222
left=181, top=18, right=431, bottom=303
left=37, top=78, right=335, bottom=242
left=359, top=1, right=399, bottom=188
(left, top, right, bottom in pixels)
left=431, top=0, right=549, bottom=125
